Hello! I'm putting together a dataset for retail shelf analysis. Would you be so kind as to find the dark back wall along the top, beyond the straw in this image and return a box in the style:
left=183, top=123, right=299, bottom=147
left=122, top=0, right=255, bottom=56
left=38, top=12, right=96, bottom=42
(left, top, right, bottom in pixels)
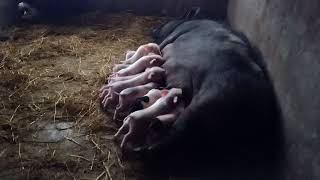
left=0, top=0, right=227, bottom=27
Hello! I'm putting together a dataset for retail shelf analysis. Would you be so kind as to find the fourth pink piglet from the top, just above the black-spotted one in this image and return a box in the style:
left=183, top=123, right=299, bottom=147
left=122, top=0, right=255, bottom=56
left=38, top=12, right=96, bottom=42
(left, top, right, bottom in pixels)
left=113, top=82, right=158, bottom=120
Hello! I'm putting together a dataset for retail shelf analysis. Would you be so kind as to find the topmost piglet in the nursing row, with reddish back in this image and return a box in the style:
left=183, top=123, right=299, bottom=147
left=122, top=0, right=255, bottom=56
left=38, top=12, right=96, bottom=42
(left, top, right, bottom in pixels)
left=123, top=43, right=161, bottom=64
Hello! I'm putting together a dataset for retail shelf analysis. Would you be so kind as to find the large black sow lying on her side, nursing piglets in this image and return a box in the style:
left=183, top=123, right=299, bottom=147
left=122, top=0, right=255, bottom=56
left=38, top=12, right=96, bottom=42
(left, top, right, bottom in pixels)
left=150, top=9, right=280, bottom=161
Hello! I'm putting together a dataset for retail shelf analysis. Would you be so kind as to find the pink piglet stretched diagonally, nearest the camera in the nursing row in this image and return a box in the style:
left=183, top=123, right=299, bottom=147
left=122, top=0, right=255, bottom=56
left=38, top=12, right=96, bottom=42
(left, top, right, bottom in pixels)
left=115, top=88, right=182, bottom=148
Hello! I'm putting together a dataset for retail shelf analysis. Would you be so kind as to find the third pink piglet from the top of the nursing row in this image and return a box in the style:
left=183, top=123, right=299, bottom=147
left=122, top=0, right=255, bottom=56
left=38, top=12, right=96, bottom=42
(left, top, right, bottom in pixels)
left=102, top=67, right=165, bottom=109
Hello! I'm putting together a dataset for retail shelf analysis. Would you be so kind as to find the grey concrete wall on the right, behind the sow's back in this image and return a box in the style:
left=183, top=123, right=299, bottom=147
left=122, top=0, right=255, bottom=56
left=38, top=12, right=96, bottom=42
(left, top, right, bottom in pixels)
left=229, top=0, right=320, bottom=180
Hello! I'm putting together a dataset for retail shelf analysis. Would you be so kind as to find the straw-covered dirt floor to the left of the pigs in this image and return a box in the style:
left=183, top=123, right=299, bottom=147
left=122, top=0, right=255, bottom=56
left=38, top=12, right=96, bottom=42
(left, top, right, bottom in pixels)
left=0, top=13, right=169, bottom=179
